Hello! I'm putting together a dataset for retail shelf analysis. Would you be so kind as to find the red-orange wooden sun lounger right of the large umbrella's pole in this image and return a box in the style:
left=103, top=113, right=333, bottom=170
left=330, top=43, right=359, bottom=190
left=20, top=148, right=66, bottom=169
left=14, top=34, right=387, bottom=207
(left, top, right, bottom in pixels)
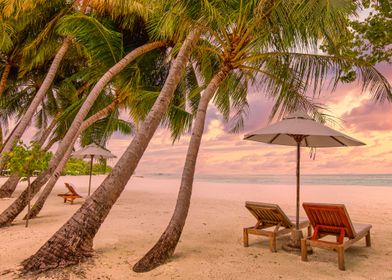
left=301, top=203, right=372, bottom=270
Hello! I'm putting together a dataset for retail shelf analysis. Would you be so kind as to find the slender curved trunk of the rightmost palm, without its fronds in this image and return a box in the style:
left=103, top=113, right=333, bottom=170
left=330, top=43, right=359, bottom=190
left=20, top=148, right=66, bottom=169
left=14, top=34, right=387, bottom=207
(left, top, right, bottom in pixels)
left=133, top=67, right=230, bottom=272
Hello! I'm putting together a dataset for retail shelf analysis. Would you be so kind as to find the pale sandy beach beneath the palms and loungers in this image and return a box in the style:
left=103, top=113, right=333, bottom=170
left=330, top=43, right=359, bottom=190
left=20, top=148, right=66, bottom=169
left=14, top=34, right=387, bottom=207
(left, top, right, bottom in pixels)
left=0, top=176, right=392, bottom=279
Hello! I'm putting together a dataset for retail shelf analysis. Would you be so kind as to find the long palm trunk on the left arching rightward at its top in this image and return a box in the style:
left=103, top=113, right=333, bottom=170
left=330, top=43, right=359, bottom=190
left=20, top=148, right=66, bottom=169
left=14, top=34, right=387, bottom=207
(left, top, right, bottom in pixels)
left=0, top=41, right=166, bottom=227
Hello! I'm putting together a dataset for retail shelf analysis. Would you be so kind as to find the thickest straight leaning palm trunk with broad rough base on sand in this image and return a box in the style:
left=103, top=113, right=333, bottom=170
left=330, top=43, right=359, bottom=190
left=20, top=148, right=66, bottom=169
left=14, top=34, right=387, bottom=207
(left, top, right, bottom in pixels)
left=22, top=29, right=200, bottom=273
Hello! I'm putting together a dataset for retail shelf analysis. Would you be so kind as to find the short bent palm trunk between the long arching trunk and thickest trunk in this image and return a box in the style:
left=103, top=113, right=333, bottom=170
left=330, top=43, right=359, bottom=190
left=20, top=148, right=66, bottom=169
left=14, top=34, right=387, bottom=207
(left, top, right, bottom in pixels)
left=23, top=100, right=118, bottom=220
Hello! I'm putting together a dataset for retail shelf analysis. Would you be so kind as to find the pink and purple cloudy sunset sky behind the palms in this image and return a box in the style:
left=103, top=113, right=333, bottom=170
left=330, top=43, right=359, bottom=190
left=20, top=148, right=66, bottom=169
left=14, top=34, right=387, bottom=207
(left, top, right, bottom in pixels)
left=101, top=64, right=392, bottom=175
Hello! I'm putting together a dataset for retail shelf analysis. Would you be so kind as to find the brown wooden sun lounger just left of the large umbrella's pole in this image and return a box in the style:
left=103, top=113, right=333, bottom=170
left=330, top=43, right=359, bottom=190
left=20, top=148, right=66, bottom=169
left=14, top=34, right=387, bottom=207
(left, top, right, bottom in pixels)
left=244, top=201, right=311, bottom=252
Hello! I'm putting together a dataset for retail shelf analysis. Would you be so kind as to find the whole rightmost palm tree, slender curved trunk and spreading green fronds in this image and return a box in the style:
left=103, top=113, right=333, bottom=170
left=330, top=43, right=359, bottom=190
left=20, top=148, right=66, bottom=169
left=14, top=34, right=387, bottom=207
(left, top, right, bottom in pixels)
left=133, top=0, right=391, bottom=272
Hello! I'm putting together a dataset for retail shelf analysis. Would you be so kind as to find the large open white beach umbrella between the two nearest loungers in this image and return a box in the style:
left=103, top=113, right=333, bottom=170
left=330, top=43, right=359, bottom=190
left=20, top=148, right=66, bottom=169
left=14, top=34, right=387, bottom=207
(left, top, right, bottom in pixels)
left=244, top=111, right=365, bottom=247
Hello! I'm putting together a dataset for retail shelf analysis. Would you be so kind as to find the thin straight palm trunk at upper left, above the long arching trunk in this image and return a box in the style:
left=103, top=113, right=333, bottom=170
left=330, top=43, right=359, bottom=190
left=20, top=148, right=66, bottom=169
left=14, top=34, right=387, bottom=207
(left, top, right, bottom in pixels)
left=0, top=37, right=71, bottom=166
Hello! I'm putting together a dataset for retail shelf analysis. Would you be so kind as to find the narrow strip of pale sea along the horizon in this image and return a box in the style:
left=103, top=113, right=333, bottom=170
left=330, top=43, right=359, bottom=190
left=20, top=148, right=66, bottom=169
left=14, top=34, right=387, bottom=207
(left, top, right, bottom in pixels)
left=143, top=173, right=392, bottom=187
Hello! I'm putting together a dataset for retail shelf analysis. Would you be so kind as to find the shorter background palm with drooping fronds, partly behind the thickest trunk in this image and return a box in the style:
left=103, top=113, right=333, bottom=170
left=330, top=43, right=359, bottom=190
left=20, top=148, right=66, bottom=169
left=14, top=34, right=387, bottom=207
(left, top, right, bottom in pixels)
left=24, top=47, right=196, bottom=219
